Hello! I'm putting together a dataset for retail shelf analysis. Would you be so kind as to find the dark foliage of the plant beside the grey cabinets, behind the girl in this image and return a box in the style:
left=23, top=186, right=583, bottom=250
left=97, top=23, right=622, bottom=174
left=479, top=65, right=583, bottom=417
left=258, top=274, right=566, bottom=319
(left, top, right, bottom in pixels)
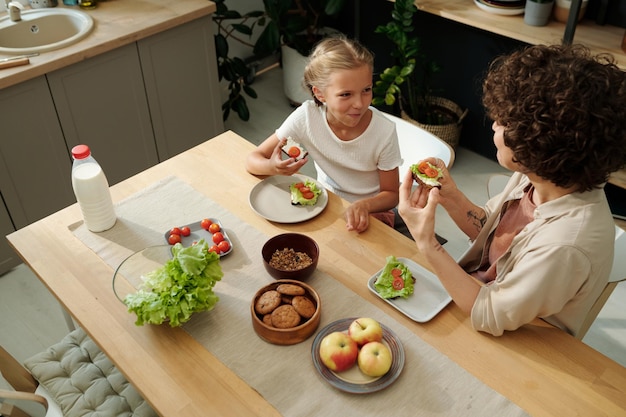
left=213, top=0, right=346, bottom=121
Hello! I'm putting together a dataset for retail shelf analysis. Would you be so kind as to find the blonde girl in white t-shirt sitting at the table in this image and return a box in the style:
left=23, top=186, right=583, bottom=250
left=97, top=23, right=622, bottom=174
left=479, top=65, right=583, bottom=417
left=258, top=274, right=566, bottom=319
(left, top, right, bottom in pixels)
left=246, top=37, right=402, bottom=233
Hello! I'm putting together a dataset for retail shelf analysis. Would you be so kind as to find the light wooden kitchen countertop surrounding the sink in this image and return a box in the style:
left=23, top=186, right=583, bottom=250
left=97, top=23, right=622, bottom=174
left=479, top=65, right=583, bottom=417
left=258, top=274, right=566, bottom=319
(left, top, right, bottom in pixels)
left=0, top=0, right=216, bottom=89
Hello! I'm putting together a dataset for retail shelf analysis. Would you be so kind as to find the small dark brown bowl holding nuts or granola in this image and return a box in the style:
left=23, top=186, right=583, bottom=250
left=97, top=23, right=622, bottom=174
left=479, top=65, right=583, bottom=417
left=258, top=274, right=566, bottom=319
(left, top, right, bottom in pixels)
left=261, top=233, right=320, bottom=280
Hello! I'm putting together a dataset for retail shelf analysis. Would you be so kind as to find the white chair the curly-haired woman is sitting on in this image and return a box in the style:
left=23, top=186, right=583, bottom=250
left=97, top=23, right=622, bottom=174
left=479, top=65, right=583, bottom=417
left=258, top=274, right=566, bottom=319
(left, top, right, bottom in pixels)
left=487, top=174, right=626, bottom=340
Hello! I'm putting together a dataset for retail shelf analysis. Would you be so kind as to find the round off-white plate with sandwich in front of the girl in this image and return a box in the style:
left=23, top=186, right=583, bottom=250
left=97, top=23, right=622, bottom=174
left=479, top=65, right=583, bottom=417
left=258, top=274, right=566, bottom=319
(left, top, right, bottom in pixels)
left=248, top=174, right=328, bottom=223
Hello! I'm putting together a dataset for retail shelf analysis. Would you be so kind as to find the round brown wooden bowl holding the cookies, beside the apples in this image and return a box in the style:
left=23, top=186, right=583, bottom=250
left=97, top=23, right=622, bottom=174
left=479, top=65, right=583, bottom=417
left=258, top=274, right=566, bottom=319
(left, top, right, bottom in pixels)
left=250, top=279, right=322, bottom=345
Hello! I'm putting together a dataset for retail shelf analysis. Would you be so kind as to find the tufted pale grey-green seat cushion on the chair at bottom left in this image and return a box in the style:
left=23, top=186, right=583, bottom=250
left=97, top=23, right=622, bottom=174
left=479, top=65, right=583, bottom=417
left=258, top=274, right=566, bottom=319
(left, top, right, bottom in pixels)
left=24, top=328, right=157, bottom=417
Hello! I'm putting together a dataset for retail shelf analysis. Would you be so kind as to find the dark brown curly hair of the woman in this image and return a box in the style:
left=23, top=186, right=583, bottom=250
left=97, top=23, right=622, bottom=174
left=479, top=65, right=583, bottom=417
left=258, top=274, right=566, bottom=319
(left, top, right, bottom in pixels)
left=483, top=45, right=626, bottom=192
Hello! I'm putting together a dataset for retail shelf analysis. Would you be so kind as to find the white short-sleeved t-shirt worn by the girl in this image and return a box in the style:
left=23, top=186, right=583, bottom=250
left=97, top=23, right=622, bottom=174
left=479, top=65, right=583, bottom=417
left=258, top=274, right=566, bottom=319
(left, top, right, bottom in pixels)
left=276, top=100, right=402, bottom=202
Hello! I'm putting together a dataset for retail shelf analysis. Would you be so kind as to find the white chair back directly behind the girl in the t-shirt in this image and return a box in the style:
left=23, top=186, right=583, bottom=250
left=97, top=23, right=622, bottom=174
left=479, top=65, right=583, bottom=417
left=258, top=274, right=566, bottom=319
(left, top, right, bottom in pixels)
left=383, top=113, right=454, bottom=178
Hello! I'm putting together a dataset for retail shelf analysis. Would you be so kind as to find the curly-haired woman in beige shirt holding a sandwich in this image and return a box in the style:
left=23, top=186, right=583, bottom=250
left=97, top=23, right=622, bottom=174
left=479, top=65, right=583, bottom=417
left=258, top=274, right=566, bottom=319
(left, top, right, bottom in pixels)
left=399, top=45, right=626, bottom=336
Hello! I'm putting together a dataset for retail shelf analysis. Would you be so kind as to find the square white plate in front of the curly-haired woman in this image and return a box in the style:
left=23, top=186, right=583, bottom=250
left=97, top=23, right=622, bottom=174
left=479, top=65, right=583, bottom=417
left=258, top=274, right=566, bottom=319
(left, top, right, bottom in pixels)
left=367, top=258, right=452, bottom=323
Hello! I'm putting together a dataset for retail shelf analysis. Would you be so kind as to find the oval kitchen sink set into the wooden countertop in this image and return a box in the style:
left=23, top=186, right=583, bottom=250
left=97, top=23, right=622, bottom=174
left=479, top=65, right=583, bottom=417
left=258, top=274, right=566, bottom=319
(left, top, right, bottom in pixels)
left=0, top=8, right=94, bottom=54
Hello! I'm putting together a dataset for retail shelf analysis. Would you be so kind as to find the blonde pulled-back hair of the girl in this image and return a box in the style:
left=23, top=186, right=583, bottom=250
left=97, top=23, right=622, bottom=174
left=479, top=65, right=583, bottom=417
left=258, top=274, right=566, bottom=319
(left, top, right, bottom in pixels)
left=304, top=35, right=374, bottom=106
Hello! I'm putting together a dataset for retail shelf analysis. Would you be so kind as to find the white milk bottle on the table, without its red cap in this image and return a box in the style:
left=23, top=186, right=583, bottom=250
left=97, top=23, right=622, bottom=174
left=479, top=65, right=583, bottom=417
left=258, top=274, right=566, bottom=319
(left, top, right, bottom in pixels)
left=72, top=158, right=116, bottom=232
